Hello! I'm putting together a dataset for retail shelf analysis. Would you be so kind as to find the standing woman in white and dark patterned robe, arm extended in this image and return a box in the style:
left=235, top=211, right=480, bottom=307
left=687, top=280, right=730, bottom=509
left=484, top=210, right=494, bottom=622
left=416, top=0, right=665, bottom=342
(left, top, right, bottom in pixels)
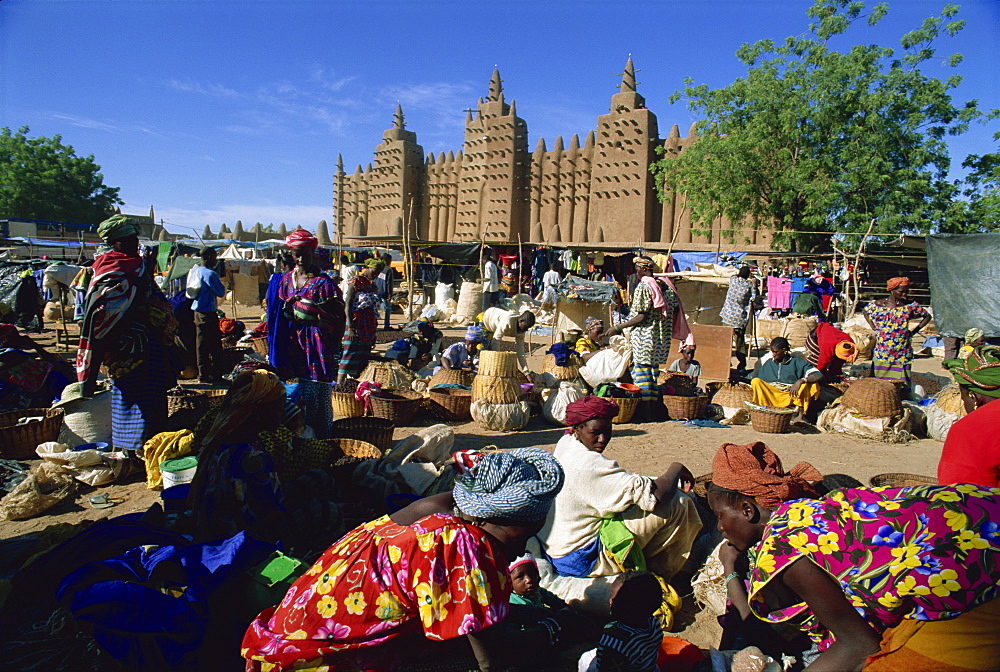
left=604, top=257, right=694, bottom=420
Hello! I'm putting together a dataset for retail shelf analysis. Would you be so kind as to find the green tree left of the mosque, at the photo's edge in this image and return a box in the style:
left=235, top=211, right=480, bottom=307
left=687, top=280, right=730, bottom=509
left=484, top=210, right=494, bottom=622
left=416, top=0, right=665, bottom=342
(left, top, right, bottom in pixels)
left=0, top=126, right=124, bottom=224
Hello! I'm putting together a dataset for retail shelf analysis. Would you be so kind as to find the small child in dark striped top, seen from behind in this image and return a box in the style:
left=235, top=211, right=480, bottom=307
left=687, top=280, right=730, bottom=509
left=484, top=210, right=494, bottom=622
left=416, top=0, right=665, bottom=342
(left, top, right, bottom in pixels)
left=579, top=571, right=663, bottom=672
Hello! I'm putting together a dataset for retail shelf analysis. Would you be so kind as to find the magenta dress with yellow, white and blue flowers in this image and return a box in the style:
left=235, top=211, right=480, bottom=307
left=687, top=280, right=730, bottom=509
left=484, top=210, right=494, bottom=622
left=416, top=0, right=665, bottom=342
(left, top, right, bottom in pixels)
left=749, top=484, right=1000, bottom=651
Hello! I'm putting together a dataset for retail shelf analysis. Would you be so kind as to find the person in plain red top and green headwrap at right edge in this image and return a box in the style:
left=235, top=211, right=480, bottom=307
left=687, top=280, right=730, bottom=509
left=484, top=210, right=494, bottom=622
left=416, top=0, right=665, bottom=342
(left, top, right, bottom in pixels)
left=938, top=345, right=1000, bottom=488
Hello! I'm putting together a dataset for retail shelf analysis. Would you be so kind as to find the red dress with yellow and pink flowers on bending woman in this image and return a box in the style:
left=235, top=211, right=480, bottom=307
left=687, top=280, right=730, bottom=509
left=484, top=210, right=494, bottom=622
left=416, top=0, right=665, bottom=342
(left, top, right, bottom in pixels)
left=242, top=514, right=510, bottom=670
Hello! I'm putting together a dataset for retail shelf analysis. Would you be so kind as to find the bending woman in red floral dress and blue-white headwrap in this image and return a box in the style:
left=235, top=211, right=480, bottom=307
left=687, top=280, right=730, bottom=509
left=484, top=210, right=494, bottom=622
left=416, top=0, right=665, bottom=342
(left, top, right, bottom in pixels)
left=242, top=448, right=563, bottom=672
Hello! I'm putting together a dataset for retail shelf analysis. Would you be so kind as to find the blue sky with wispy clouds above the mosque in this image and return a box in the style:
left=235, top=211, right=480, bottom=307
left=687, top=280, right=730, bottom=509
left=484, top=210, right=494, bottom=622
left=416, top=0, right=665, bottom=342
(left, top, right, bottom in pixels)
left=0, top=0, right=1000, bottom=239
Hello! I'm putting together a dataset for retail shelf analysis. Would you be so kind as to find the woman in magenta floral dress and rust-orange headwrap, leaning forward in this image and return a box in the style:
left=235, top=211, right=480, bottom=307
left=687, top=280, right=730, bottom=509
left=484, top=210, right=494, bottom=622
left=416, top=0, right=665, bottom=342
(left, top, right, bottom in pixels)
left=708, top=444, right=1000, bottom=672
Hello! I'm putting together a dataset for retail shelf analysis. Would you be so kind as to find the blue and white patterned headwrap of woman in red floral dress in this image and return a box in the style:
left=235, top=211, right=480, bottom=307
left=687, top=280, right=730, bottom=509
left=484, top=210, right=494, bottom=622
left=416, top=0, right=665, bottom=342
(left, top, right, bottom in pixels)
left=453, top=448, right=564, bottom=522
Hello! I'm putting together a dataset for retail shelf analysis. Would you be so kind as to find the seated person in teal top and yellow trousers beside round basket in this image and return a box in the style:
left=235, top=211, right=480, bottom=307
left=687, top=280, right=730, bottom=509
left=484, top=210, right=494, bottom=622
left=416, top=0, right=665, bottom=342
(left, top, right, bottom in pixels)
left=750, top=336, right=823, bottom=413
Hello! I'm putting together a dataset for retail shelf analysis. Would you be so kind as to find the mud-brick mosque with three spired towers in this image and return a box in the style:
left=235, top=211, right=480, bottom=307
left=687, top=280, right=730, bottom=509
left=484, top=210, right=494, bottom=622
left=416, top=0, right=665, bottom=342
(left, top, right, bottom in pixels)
left=333, top=58, right=770, bottom=250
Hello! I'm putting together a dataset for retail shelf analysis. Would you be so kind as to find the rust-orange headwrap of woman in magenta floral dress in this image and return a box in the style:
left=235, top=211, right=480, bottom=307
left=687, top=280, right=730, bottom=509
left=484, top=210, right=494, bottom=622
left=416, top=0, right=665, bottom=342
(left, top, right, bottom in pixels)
left=712, top=441, right=823, bottom=511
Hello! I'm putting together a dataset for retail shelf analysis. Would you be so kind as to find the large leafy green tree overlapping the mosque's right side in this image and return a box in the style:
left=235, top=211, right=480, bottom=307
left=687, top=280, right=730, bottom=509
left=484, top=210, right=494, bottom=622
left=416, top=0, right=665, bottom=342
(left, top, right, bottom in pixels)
left=651, top=0, right=981, bottom=251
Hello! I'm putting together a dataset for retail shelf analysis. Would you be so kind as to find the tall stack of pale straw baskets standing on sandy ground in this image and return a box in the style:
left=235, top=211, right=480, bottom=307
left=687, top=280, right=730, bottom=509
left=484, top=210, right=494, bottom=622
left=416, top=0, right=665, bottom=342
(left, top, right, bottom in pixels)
left=469, top=350, right=531, bottom=431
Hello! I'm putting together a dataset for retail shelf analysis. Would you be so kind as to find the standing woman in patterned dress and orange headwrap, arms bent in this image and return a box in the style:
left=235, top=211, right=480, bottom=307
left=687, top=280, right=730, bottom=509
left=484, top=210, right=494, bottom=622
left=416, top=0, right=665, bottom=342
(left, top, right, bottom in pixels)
left=865, top=278, right=931, bottom=387
